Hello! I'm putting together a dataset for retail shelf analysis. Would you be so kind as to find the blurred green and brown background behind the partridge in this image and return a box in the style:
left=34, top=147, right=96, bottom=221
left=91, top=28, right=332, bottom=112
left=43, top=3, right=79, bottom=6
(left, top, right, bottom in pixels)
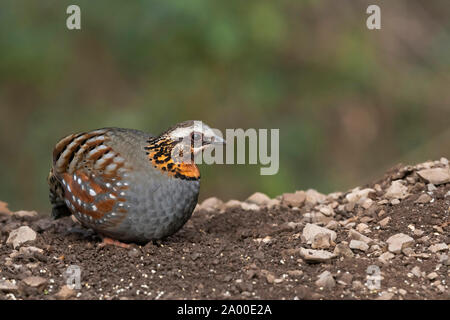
left=0, top=0, right=450, bottom=212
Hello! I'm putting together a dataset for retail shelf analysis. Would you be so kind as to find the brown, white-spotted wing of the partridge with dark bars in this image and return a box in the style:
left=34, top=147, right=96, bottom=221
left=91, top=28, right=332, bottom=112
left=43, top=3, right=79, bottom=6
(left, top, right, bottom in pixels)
left=53, top=129, right=130, bottom=228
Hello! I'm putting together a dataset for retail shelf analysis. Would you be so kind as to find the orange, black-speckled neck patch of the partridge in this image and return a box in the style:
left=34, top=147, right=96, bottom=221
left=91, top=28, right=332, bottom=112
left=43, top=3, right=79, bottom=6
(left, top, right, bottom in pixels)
left=145, top=138, right=200, bottom=180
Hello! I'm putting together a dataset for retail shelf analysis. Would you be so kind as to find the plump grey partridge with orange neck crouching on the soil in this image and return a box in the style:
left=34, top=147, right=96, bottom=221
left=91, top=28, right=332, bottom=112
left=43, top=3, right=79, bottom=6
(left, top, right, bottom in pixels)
left=47, top=120, right=225, bottom=243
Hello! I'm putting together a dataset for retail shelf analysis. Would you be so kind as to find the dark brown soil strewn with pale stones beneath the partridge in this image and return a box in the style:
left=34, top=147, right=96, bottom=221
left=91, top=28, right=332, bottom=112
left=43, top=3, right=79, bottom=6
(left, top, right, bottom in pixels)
left=0, top=158, right=450, bottom=299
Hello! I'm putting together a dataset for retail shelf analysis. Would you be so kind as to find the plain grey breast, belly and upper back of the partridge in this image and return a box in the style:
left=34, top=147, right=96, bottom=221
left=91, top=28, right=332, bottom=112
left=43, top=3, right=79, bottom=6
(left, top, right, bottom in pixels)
left=103, top=129, right=200, bottom=242
